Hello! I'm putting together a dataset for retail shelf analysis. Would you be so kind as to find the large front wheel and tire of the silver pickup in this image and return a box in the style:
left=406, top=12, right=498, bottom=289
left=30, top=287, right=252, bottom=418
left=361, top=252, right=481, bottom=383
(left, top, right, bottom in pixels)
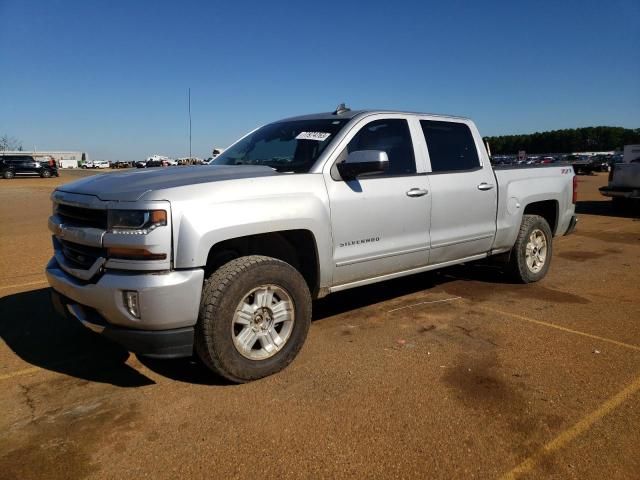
left=195, top=255, right=311, bottom=383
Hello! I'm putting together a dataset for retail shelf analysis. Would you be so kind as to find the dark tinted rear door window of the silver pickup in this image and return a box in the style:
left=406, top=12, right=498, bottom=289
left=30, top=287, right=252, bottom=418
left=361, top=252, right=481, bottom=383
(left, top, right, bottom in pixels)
left=420, top=120, right=480, bottom=172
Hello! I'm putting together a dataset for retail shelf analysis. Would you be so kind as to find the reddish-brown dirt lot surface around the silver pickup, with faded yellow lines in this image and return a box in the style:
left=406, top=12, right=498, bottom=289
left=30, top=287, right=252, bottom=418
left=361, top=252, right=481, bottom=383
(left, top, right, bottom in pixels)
left=0, top=171, right=640, bottom=480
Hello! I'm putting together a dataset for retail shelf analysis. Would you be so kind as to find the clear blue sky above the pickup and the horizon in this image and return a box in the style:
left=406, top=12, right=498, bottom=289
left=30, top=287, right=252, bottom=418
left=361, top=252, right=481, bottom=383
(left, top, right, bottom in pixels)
left=0, top=0, right=640, bottom=160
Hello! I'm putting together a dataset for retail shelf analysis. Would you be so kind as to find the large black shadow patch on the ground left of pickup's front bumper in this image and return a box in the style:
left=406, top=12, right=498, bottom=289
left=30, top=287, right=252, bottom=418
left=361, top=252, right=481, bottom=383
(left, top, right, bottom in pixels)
left=0, top=288, right=154, bottom=387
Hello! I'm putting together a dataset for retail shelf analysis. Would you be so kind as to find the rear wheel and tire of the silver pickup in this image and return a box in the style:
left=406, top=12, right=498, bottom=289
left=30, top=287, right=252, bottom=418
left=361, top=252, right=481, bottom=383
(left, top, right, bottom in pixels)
left=509, top=215, right=553, bottom=283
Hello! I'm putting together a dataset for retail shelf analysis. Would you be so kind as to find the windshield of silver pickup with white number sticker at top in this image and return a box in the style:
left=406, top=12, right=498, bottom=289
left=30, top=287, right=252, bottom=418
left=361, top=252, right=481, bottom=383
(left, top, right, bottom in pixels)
left=211, top=119, right=348, bottom=173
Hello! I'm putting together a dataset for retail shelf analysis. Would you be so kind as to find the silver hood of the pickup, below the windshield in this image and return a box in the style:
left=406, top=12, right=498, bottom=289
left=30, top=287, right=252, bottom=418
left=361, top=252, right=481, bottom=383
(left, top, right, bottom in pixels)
left=57, top=165, right=278, bottom=202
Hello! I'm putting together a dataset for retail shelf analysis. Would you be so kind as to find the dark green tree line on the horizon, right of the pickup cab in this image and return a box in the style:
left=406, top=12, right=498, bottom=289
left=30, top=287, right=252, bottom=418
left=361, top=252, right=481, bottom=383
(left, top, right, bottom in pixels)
left=485, top=127, right=640, bottom=155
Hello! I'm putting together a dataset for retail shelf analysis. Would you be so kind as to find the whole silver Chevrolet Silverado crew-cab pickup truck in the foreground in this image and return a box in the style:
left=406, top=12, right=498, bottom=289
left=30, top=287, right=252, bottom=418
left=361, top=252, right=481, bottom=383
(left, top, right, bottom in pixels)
left=46, top=108, right=576, bottom=382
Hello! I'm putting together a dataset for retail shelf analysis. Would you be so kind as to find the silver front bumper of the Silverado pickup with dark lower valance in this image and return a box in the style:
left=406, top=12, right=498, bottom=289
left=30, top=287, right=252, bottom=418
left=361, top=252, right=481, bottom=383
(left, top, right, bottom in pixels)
left=46, top=258, right=204, bottom=358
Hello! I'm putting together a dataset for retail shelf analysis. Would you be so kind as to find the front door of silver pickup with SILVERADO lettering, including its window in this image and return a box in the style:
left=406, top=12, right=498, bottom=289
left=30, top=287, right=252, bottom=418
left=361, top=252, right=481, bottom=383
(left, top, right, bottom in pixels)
left=325, top=115, right=431, bottom=285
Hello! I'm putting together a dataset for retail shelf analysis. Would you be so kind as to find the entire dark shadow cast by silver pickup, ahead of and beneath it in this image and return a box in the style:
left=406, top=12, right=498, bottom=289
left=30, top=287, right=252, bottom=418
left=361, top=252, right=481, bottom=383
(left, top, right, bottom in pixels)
left=0, top=264, right=524, bottom=387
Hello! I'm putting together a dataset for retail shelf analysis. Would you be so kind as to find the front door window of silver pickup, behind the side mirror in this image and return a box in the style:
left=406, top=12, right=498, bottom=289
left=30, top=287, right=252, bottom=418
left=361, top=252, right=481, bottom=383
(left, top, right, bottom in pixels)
left=347, top=119, right=416, bottom=175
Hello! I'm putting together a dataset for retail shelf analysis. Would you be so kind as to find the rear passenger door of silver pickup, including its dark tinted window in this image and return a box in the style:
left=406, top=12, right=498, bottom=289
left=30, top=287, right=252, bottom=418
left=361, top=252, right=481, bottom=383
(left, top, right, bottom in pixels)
left=420, top=119, right=497, bottom=264
